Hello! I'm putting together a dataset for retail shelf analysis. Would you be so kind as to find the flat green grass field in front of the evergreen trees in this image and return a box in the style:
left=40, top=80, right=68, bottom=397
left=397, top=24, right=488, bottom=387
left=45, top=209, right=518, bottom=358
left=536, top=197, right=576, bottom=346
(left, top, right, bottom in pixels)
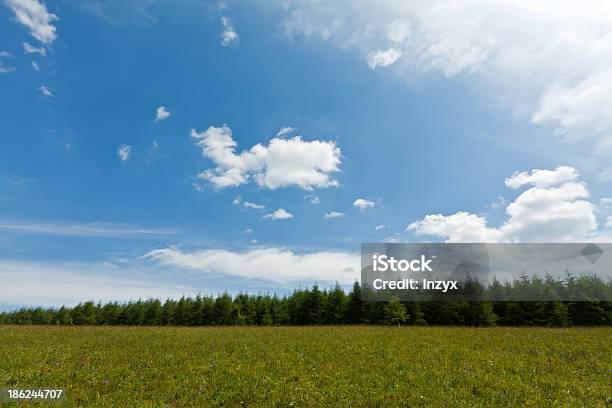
left=0, top=326, right=612, bottom=407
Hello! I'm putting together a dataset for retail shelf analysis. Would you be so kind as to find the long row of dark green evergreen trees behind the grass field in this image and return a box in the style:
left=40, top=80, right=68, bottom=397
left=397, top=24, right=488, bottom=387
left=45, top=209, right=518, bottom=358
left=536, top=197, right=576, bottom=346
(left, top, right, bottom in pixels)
left=0, top=282, right=612, bottom=326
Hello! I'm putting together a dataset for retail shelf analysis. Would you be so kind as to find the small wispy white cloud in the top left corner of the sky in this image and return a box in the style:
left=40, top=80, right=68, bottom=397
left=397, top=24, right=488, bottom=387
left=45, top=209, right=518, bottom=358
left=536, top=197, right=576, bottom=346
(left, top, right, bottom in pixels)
left=4, top=0, right=58, bottom=45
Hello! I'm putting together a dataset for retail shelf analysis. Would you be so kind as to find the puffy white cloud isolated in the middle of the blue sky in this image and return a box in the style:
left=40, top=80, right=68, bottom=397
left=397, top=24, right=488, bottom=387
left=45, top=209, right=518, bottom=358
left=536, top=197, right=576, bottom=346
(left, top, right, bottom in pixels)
left=191, top=125, right=341, bottom=190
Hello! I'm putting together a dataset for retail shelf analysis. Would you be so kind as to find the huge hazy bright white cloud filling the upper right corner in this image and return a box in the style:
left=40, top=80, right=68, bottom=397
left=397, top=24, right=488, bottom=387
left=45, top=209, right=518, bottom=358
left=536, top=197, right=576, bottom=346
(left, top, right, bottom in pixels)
left=277, top=0, right=612, bottom=159
